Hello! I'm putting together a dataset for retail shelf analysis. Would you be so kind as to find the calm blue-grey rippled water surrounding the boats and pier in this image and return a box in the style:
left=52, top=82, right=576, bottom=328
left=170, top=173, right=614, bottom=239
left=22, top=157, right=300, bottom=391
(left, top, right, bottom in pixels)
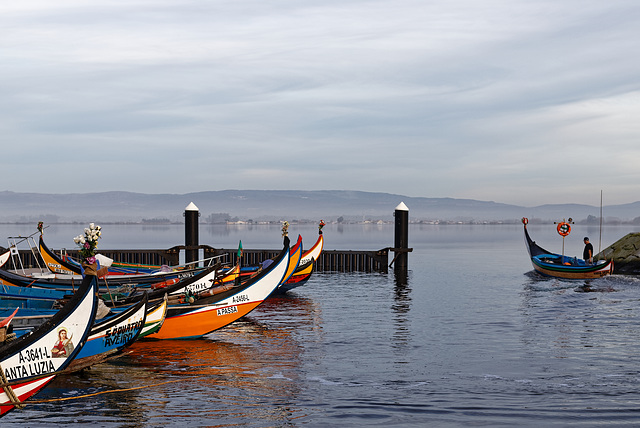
left=0, top=225, right=640, bottom=427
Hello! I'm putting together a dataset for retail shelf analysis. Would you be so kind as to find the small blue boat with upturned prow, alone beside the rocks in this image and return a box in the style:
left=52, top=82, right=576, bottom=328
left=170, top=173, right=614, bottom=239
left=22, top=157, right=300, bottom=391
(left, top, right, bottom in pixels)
left=522, top=218, right=613, bottom=279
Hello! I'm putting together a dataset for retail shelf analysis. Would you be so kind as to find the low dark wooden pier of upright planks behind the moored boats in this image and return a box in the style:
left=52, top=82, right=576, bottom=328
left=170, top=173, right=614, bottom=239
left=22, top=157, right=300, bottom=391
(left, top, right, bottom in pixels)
left=4, top=245, right=393, bottom=272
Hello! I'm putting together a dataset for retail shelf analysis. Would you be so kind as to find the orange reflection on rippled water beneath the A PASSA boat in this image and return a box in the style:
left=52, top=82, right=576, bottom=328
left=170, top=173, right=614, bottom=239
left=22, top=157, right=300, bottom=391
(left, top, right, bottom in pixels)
left=127, top=296, right=320, bottom=378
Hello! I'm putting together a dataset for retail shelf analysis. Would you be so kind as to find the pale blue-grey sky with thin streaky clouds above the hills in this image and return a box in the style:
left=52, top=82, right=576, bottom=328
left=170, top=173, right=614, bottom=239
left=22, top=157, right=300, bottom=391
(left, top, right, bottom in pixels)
left=0, top=0, right=640, bottom=206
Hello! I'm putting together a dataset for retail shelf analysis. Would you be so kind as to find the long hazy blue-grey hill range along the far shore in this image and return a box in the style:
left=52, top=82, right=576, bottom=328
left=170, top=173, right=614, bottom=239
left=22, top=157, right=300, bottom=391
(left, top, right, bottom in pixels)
left=0, top=190, right=640, bottom=223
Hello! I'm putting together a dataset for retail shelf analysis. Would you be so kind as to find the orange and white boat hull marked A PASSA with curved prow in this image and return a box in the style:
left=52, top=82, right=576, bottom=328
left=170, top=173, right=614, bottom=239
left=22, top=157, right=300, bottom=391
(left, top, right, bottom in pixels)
left=149, top=236, right=292, bottom=339
